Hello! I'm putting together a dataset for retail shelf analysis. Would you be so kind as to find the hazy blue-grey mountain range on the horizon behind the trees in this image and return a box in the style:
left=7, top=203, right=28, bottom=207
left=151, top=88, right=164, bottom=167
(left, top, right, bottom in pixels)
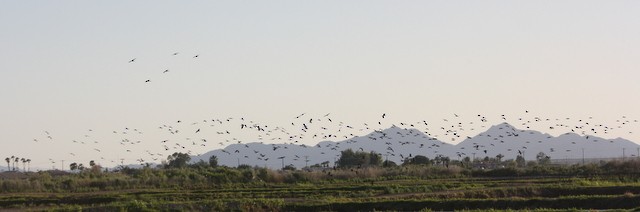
left=191, top=123, right=640, bottom=168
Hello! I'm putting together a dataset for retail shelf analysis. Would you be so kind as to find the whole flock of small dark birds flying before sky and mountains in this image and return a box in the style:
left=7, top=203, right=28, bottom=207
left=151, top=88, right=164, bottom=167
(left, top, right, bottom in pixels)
left=16, top=52, right=638, bottom=169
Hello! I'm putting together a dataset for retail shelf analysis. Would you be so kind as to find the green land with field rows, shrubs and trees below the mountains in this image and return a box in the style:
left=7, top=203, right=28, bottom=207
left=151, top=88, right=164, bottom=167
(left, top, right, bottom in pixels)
left=0, top=151, right=640, bottom=211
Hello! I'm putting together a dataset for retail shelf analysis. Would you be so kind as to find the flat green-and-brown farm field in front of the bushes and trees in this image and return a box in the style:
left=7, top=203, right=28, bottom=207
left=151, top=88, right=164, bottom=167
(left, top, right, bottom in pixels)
left=0, top=170, right=640, bottom=211
